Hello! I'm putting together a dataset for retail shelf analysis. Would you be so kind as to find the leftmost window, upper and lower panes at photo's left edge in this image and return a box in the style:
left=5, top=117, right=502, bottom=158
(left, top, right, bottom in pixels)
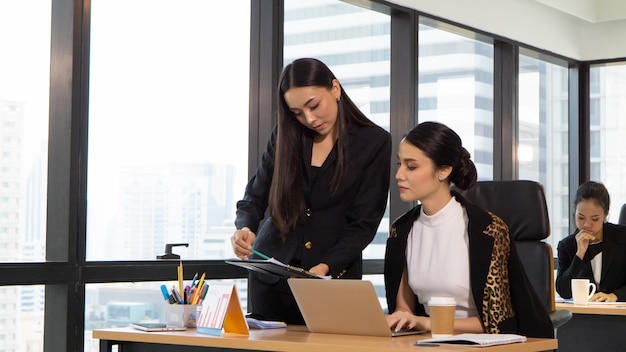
left=0, top=0, right=51, bottom=352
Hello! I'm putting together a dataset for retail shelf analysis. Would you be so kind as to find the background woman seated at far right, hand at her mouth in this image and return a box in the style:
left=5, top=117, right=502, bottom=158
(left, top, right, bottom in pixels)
left=556, top=181, right=626, bottom=302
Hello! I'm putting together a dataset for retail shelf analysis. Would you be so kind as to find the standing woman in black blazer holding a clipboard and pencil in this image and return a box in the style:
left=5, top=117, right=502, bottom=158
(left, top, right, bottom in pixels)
left=231, top=59, right=391, bottom=324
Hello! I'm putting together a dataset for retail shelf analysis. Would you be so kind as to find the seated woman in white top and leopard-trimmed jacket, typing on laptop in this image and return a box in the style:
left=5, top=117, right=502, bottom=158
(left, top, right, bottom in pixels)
left=385, top=122, right=554, bottom=338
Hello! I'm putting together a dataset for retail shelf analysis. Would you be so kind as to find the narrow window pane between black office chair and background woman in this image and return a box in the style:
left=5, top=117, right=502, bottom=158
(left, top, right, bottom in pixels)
left=517, top=50, right=572, bottom=248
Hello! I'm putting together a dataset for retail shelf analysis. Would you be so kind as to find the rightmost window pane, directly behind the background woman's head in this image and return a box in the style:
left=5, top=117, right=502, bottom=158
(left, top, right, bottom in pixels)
left=589, top=62, right=626, bottom=223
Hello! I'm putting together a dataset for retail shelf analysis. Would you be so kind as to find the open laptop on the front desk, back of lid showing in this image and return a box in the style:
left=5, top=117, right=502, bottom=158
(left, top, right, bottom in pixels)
left=287, top=278, right=424, bottom=337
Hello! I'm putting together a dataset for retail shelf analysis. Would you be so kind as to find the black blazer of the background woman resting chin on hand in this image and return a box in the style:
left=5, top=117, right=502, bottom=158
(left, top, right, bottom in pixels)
left=556, top=222, right=626, bottom=301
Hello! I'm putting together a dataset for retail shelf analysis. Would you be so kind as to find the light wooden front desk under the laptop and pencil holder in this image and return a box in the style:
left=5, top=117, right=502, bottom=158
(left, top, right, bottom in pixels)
left=93, top=328, right=557, bottom=352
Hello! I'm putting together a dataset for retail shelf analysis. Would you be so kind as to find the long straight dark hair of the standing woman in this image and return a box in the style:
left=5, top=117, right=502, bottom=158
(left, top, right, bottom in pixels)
left=269, top=58, right=374, bottom=239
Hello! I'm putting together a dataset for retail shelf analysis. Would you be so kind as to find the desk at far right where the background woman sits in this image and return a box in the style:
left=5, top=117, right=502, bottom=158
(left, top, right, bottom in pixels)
left=556, top=302, right=626, bottom=352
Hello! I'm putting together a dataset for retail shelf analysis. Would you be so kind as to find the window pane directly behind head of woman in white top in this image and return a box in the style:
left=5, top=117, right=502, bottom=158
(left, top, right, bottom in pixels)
left=418, top=18, right=494, bottom=180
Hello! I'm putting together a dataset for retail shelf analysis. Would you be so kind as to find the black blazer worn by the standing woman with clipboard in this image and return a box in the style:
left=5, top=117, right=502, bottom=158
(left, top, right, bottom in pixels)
left=235, top=124, right=391, bottom=283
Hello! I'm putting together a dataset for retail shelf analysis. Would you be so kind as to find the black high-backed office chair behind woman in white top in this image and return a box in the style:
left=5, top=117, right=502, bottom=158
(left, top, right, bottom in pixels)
left=457, top=180, right=572, bottom=336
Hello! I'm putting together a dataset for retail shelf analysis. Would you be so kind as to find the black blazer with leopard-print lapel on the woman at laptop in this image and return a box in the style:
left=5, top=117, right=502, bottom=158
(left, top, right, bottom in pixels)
left=385, top=192, right=554, bottom=338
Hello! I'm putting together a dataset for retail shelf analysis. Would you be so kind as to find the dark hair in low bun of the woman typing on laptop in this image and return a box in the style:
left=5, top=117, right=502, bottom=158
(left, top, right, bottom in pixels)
left=404, top=121, right=478, bottom=190
